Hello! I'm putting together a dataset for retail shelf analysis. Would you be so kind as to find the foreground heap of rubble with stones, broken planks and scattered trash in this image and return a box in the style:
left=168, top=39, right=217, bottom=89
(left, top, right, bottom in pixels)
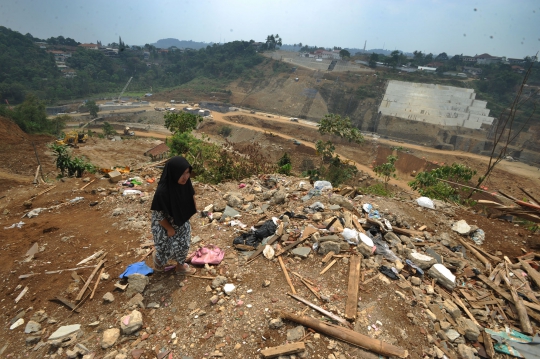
left=4, top=173, right=540, bottom=359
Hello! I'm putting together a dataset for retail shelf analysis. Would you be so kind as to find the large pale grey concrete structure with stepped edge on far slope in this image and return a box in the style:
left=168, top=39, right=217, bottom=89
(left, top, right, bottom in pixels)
left=379, top=80, right=493, bottom=129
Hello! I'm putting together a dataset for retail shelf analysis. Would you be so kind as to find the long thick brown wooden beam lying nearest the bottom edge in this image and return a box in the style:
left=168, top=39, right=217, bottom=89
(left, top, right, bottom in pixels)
left=281, top=311, right=409, bottom=358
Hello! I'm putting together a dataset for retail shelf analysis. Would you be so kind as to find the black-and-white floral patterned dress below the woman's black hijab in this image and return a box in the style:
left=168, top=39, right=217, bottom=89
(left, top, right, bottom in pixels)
left=152, top=211, right=191, bottom=266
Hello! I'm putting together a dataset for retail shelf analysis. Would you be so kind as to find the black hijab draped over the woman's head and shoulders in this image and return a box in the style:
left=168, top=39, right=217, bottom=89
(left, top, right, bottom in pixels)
left=150, top=156, right=197, bottom=226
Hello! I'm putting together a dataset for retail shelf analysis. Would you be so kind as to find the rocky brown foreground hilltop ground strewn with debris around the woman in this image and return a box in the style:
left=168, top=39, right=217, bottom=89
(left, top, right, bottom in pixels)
left=0, top=162, right=536, bottom=359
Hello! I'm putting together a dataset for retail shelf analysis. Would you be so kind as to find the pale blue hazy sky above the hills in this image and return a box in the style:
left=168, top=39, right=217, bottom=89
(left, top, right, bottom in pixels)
left=0, top=0, right=540, bottom=58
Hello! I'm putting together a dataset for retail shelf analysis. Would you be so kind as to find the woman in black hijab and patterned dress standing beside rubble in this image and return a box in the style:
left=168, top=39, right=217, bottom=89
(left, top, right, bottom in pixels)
left=150, top=156, right=197, bottom=274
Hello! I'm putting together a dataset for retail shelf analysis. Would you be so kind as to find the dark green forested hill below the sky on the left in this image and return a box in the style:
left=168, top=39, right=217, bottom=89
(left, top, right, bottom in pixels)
left=0, top=27, right=263, bottom=104
